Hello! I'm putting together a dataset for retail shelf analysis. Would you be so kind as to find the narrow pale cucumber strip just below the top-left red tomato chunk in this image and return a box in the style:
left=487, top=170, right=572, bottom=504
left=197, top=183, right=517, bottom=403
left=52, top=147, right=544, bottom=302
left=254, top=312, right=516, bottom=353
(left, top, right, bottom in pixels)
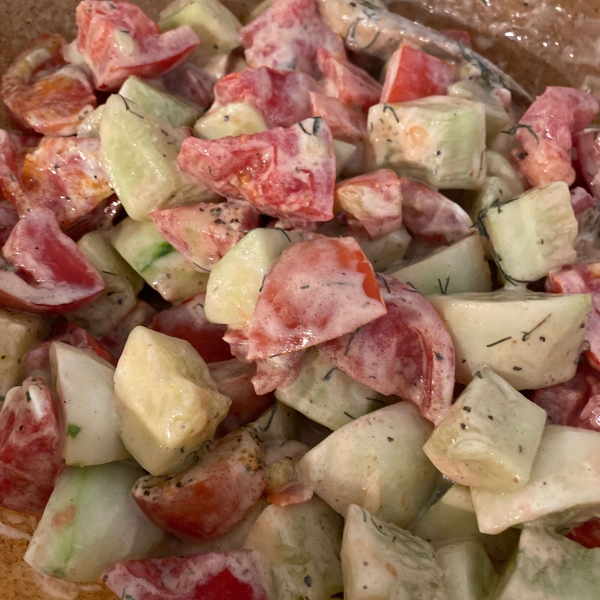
left=119, top=75, right=200, bottom=129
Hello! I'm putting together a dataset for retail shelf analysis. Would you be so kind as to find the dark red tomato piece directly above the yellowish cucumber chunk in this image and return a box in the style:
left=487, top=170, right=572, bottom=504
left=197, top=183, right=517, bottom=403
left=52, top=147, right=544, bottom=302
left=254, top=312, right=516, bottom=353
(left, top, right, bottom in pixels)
left=151, top=293, right=232, bottom=360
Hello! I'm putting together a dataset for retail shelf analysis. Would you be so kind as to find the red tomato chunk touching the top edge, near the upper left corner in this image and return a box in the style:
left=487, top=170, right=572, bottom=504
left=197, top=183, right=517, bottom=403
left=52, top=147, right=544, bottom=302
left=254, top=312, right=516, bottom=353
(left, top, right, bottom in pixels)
left=76, top=0, right=199, bottom=90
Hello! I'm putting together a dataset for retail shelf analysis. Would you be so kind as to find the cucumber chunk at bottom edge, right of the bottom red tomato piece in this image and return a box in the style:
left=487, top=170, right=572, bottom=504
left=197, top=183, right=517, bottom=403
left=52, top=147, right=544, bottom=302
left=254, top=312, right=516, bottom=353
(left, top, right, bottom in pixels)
left=245, top=498, right=343, bottom=600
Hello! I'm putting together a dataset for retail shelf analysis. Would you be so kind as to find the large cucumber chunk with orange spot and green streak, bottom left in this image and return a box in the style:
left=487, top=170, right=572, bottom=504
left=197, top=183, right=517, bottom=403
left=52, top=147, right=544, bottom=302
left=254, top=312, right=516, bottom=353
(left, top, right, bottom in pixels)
left=25, top=462, right=164, bottom=581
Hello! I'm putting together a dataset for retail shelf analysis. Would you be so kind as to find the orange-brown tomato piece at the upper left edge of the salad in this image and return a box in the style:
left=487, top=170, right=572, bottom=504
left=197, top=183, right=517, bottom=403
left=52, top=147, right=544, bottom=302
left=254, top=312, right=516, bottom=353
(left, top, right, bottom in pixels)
left=2, top=35, right=96, bottom=135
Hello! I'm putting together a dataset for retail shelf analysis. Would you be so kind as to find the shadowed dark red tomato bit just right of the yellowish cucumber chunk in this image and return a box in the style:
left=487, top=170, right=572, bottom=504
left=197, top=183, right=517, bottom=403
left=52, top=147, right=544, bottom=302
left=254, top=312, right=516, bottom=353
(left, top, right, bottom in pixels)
left=208, top=358, right=275, bottom=437
